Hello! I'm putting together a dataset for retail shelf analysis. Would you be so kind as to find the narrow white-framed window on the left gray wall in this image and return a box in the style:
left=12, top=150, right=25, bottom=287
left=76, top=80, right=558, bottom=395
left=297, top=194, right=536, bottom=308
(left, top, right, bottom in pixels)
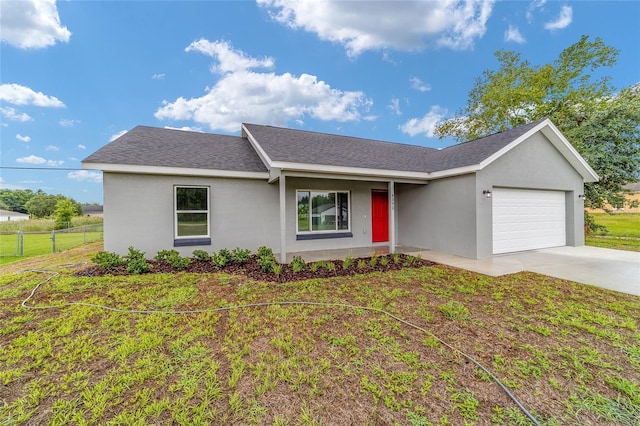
left=175, top=186, right=209, bottom=239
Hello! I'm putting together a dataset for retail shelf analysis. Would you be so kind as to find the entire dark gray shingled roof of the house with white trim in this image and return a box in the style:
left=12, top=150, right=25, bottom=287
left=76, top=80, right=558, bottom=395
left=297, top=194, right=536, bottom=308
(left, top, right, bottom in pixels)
left=83, top=120, right=598, bottom=182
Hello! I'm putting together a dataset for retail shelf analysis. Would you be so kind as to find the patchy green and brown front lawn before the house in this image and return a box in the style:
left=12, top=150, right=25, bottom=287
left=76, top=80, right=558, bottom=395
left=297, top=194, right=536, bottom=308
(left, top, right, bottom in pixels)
left=0, top=245, right=640, bottom=425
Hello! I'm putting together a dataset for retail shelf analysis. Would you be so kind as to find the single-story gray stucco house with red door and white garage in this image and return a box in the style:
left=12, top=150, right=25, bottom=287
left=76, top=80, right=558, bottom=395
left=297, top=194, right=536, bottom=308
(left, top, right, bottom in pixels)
left=83, top=120, right=598, bottom=262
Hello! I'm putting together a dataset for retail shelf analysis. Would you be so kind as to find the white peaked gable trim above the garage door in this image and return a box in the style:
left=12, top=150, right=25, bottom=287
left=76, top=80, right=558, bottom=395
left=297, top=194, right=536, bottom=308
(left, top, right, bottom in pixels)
left=480, top=119, right=599, bottom=182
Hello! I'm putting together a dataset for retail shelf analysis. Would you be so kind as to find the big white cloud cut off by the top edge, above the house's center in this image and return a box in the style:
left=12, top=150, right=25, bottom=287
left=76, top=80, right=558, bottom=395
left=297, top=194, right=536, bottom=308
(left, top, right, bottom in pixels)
left=258, top=0, right=495, bottom=57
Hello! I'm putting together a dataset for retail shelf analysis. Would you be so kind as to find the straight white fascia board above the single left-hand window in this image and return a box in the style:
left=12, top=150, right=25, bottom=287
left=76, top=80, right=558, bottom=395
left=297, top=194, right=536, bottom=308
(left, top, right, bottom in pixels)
left=82, top=163, right=269, bottom=180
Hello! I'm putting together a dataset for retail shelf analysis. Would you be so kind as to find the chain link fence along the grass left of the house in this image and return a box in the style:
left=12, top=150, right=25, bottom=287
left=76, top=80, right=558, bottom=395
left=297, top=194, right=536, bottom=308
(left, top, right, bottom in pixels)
left=0, top=223, right=103, bottom=257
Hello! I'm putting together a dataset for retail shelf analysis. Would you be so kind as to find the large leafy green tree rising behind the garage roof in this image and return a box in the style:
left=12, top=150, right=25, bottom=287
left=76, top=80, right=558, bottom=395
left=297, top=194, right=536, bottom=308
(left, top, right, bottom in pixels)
left=436, top=36, right=640, bottom=207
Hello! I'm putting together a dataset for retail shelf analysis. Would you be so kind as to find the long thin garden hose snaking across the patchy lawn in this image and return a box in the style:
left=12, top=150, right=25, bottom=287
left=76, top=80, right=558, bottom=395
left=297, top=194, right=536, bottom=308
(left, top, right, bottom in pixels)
left=20, top=264, right=540, bottom=426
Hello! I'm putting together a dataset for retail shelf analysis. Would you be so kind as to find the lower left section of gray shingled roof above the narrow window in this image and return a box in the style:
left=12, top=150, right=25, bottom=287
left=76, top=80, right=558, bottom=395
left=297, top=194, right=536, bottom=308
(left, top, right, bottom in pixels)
left=82, top=126, right=267, bottom=172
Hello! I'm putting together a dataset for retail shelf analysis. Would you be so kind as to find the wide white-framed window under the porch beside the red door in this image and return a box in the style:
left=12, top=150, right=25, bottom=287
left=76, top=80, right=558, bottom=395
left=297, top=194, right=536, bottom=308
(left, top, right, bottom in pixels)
left=297, top=191, right=350, bottom=233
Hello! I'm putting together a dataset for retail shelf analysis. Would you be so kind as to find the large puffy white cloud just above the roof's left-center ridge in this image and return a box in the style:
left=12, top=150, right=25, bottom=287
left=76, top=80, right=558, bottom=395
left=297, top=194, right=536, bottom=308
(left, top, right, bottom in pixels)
left=155, top=40, right=372, bottom=132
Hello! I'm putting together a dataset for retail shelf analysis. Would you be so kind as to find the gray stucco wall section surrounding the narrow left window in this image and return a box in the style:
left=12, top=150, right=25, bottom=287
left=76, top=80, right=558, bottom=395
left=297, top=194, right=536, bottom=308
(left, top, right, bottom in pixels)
left=103, top=173, right=279, bottom=258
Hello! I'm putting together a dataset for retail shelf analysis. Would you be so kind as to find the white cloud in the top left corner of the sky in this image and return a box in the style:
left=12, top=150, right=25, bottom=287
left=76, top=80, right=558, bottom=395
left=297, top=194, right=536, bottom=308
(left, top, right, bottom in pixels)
left=0, top=0, right=71, bottom=49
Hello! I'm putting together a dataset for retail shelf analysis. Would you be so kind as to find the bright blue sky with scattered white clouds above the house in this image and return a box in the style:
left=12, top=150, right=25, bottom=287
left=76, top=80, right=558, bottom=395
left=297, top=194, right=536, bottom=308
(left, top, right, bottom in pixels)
left=0, top=0, right=640, bottom=203
